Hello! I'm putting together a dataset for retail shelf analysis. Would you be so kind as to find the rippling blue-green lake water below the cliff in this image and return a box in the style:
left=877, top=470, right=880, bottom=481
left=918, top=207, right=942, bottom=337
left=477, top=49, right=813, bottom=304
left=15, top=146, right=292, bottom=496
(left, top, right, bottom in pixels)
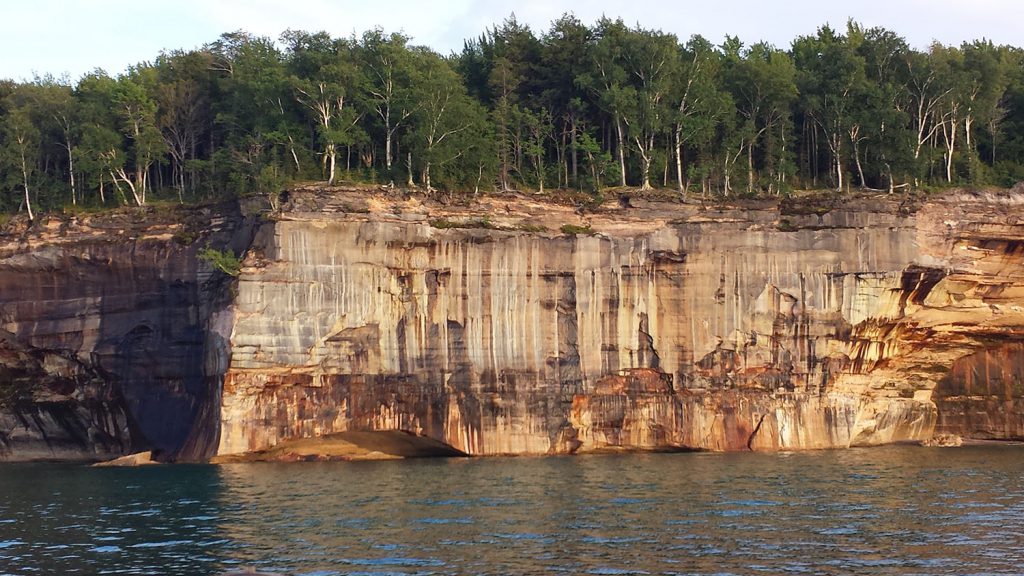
left=0, top=446, right=1024, bottom=576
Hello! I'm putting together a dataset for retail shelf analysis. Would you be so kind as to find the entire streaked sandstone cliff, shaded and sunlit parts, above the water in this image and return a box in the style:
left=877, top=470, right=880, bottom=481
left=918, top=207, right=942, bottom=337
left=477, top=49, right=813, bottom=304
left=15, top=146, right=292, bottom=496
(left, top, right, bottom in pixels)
left=0, top=190, right=1024, bottom=458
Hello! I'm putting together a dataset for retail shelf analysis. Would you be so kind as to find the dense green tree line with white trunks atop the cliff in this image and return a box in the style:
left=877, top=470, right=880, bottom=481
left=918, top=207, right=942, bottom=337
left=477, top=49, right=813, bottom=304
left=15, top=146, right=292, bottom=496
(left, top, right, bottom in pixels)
left=0, top=14, right=1024, bottom=216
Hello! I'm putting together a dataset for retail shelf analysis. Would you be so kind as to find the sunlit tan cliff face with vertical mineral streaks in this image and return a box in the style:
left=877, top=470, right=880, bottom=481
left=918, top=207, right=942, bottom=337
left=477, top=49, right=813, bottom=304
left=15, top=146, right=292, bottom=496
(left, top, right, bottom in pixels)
left=217, top=188, right=1024, bottom=454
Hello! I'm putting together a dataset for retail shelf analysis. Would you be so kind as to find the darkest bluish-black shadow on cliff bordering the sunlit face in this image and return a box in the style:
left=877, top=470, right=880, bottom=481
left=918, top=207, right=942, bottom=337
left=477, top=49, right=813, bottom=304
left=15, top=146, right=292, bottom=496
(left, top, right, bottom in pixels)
left=86, top=207, right=257, bottom=461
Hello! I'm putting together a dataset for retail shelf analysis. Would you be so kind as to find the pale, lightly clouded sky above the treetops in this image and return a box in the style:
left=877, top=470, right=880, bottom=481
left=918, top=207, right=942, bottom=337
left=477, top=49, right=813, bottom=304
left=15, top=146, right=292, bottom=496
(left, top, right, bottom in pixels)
left=0, top=0, right=1024, bottom=81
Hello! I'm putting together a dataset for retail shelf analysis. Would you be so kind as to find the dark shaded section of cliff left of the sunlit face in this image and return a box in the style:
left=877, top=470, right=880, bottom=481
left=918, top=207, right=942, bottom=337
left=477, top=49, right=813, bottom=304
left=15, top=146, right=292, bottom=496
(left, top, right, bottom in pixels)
left=0, top=206, right=250, bottom=460
